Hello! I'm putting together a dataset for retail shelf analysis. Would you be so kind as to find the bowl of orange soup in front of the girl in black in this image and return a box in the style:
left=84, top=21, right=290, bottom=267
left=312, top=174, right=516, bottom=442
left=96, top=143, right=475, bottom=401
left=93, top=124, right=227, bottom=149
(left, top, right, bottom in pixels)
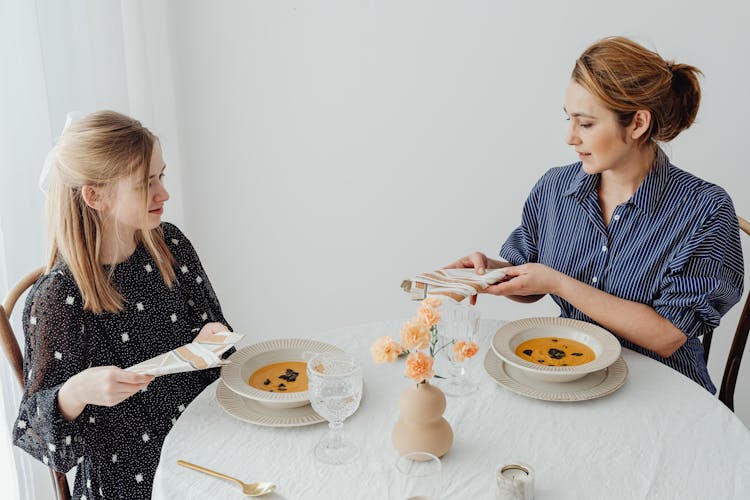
left=221, top=339, right=341, bottom=408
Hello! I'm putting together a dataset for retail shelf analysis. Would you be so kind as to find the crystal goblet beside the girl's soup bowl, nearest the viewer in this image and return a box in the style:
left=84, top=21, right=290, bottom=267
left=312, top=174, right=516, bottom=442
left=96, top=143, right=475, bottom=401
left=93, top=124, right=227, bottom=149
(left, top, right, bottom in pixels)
left=307, top=352, right=362, bottom=465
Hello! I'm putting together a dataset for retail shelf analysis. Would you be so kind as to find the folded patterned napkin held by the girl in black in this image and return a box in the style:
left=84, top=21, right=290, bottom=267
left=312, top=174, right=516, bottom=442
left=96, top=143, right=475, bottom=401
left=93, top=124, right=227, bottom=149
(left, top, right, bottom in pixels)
left=126, top=332, right=244, bottom=377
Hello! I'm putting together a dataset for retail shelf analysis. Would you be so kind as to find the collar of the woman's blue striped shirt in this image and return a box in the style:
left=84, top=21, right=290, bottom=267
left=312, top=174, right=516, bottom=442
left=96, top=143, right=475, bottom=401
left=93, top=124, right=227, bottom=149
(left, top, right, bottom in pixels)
left=564, top=146, right=670, bottom=212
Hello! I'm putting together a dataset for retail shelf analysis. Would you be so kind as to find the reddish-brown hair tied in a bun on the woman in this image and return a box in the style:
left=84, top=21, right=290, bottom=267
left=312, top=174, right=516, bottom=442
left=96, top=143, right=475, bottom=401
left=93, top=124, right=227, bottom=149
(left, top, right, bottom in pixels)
left=571, top=36, right=701, bottom=142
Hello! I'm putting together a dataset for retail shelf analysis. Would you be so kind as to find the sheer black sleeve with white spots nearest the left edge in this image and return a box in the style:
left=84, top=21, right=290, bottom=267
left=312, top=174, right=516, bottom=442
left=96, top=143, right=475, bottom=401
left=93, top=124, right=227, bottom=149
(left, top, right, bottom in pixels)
left=13, top=271, right=89, bottom=472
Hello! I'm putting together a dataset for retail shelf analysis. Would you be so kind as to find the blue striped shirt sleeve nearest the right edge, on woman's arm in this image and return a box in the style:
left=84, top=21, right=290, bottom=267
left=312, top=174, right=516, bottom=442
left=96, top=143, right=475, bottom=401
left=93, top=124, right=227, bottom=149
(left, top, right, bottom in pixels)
left=653, top=195, right=744, bottom=338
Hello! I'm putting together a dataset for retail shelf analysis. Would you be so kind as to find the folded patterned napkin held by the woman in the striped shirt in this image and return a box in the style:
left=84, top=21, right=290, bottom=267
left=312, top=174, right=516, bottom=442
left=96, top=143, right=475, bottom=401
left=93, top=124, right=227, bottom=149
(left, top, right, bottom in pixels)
left=401, top=268, right=505, bottom=302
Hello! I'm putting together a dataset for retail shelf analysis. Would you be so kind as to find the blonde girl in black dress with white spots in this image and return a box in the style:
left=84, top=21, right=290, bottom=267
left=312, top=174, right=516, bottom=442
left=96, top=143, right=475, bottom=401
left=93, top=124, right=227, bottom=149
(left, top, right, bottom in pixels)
left=14, top=111, right=228, bottom=498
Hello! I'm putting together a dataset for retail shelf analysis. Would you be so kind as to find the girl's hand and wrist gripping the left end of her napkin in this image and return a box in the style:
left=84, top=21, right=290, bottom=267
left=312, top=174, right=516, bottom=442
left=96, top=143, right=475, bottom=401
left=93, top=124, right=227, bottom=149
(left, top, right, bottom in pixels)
left=57, top=366, right=154, bottom=420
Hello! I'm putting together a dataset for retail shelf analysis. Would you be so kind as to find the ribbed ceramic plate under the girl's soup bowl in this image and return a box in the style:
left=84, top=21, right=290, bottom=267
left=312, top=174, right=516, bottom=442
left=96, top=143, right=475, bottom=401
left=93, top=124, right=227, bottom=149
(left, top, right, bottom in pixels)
left=216, top=381, right=325, bottom=427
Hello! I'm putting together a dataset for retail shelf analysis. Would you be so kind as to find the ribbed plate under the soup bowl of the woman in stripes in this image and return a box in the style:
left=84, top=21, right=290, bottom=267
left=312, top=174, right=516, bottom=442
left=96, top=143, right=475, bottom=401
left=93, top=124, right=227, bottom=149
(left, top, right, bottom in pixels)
left=484, top=349, right=628, bottom=401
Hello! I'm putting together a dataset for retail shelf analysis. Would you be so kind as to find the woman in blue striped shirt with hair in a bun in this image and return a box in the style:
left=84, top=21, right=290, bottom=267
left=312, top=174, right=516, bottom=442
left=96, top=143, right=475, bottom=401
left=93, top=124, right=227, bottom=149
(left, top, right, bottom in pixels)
left=449, top=37, right=744, bottom=393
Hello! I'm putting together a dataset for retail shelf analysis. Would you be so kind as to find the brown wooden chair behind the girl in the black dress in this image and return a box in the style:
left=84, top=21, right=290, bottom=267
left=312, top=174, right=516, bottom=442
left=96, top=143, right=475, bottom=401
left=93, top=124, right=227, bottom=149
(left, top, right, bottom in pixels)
left=0, top=267, right=70, bottom=500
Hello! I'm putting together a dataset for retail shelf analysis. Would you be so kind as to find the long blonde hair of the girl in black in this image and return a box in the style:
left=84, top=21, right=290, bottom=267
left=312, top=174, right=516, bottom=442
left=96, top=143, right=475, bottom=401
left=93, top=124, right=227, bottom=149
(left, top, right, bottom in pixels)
left=47, top=111, right=175, bottom=314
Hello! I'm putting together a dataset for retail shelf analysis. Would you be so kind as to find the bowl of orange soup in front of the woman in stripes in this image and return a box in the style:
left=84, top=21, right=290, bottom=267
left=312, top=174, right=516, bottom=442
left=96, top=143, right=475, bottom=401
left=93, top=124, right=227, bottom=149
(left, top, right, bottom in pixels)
left=492, top=318, right=621, bottom=382
